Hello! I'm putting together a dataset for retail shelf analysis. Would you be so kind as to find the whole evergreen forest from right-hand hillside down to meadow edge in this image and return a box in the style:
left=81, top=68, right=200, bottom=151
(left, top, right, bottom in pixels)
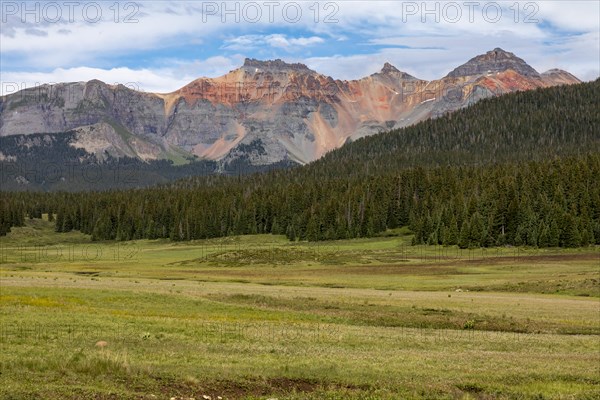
left=0, top=81, right=600, bottom=247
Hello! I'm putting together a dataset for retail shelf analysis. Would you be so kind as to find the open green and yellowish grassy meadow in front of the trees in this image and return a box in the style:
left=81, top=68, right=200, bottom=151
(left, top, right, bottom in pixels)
left=0, top=220, right=600, bottom=399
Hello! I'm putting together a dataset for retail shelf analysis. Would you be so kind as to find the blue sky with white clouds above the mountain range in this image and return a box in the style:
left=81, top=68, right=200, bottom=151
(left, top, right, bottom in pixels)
left=0, top=0, right=600, bottom=94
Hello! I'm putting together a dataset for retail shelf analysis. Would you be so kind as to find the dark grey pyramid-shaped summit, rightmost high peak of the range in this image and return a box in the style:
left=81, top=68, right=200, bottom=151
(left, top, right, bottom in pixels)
left=447, top=47, right=540, bottom=78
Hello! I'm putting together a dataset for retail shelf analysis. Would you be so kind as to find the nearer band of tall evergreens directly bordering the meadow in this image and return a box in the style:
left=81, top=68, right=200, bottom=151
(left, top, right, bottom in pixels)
left=2, top=154, right=600, bottom=248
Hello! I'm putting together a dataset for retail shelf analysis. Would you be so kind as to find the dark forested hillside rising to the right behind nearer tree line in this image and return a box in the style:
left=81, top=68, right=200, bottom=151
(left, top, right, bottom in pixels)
left=305, top=79, right=600, bottom=177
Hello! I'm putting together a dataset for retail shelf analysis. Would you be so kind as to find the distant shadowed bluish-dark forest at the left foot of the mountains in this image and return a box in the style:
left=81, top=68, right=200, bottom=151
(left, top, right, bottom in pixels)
left=0, top=131, right=297, bottom=192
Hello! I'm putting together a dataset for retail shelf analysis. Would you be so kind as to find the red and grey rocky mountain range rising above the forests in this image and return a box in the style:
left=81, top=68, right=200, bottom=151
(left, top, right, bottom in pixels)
left=0, top=49, right=580, bottom=164
